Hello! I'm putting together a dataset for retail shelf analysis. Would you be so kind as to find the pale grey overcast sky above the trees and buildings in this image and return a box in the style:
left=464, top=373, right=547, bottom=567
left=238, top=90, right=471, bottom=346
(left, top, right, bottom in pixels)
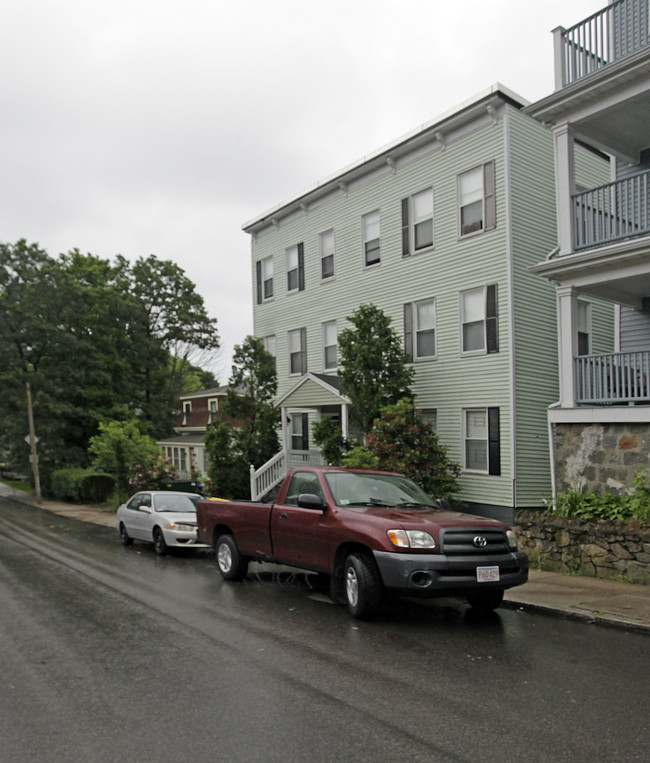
left=0, top=0, right=606, bottom=384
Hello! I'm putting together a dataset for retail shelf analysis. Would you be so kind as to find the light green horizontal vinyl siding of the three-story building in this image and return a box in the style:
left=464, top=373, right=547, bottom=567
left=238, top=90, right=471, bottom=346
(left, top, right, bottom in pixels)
left=252, top=98, right=568, bottom=506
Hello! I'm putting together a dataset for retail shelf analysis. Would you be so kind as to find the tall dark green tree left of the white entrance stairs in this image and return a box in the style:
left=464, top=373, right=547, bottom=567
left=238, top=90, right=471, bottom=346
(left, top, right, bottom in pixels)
left=205, top=336, right=280, bottom=498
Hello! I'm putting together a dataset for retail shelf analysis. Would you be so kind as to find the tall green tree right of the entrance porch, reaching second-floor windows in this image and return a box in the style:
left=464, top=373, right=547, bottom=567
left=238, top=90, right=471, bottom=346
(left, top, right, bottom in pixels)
left=338, top=305, right=414, bottom=433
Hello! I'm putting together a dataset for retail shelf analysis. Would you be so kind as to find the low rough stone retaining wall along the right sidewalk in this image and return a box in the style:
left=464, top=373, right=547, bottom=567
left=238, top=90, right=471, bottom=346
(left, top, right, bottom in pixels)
left=515, top=510, right=650, bottom=585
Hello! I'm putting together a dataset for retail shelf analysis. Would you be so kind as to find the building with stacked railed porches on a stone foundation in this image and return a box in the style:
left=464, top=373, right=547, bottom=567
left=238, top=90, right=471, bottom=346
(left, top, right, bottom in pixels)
left=526, top=0, right=650, bottom=492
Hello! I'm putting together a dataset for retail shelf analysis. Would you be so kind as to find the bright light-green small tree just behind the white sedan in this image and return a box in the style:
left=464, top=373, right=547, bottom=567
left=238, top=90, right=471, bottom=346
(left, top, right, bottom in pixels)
left=89, top=419, right=173, bottom=501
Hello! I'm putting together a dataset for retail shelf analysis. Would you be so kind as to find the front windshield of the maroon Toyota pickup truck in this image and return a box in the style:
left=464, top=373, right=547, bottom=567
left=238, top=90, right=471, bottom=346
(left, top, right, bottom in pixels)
left=325, top=472, right=438, bottom=509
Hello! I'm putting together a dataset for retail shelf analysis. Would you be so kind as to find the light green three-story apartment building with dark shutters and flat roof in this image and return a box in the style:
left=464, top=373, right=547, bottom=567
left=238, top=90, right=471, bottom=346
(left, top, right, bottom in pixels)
left=243, top=85, right=614, bottom=520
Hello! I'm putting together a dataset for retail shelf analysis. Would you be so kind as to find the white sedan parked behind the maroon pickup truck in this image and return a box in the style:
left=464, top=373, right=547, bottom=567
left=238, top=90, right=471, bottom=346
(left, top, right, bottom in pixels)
left=116, top=490, right=208, bottom=555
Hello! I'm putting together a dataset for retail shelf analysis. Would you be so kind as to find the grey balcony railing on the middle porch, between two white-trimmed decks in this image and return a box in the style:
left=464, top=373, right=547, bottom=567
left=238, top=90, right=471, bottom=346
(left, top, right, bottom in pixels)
left=572, top=172, right=650, bottom=250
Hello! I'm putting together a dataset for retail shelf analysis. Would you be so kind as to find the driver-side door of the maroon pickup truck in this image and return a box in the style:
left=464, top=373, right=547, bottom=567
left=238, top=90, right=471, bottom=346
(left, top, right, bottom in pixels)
left=271, top=472, right=331, bottom=570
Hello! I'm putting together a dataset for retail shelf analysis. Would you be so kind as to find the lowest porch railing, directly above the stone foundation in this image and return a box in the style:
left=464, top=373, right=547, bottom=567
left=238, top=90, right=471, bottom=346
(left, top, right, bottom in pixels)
left=575, top=352, right=650, bottom=405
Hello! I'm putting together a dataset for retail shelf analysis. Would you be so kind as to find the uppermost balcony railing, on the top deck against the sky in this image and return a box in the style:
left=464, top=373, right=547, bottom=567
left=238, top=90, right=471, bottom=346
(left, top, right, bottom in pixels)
left=556, top=0, right=650, bottom=87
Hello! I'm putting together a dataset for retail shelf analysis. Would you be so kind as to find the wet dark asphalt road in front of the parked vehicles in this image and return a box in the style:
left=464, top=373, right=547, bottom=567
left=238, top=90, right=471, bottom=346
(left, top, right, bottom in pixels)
left=0, top=500, right=650, bottom=763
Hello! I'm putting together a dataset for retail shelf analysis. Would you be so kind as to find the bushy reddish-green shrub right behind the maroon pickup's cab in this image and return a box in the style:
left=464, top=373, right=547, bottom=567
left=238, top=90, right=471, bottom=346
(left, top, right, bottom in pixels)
left=343, top=399, right=460, bottom=498
